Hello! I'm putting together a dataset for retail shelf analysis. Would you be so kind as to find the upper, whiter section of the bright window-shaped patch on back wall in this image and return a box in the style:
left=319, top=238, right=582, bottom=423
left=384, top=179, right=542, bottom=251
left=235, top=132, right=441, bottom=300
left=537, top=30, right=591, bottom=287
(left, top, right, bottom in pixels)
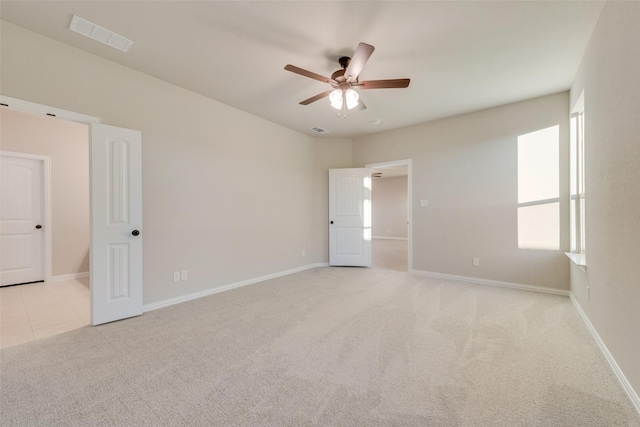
left=518, top=126, right=560, bottom=203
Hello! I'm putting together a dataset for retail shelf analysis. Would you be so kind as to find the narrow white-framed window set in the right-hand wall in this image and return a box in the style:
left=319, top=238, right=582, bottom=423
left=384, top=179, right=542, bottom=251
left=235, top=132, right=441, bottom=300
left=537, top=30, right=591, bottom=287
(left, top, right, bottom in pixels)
left=569, top=94, right=587, bottom=254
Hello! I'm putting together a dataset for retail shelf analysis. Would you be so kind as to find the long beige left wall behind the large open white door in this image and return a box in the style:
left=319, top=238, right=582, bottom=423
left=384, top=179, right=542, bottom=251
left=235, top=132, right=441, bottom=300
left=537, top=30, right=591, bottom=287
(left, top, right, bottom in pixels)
left=1, top=22, right=351, bottom=304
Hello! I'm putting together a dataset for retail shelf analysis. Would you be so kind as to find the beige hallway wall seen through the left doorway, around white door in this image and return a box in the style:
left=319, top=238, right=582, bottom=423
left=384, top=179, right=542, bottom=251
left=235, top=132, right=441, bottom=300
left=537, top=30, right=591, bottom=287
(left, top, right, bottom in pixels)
left=0, top=108, right=89, bottom=276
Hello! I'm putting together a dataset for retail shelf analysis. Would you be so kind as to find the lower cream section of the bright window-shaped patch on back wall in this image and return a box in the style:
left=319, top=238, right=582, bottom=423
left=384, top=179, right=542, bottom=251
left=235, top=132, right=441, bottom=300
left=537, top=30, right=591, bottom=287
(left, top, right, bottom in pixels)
left=518, top=202, right=560, bottom=250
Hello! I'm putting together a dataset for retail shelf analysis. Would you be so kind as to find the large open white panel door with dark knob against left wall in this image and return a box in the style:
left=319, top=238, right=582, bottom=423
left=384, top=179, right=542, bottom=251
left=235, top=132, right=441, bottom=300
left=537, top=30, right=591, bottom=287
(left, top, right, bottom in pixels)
left=91, top=123, right=143, bottom=325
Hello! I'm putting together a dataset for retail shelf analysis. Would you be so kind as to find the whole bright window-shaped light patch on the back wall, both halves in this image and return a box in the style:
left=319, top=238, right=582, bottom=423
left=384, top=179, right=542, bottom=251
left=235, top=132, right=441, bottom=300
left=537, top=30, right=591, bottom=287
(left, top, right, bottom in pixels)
left=518, top=125, right=560, bottom=250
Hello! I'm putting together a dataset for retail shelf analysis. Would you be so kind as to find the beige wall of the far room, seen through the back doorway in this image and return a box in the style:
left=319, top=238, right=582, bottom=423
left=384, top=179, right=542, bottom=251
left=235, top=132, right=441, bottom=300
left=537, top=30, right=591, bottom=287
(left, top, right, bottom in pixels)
left=371, top=176, right=407, bottom=239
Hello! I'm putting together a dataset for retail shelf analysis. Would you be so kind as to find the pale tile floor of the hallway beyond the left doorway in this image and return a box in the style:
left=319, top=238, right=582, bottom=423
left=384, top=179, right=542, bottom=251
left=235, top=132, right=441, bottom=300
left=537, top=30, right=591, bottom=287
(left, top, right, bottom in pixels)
left=0, top=277, right=91, bottom=348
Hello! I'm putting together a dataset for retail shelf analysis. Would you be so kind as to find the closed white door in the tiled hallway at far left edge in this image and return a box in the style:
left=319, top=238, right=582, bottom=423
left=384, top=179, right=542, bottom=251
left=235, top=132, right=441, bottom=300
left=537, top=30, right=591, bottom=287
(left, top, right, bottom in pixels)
left=0, top=154, right=48, bottom=286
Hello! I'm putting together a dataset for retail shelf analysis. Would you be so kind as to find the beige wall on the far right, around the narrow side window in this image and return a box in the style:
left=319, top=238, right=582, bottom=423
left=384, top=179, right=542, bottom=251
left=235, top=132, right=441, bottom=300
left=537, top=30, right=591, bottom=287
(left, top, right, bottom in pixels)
left=571, top=2, right=640, bottom=393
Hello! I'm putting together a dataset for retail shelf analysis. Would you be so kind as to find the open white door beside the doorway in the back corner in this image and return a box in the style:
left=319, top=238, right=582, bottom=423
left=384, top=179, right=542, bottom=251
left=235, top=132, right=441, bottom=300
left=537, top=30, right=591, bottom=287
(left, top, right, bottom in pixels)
left=329, top=168, right=371, bottom=267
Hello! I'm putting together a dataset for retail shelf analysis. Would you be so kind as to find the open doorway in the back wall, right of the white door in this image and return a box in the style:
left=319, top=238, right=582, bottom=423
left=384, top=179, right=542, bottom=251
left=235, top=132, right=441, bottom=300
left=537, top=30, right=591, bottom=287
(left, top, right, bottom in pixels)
left=367, top=160, right=411, bottom=272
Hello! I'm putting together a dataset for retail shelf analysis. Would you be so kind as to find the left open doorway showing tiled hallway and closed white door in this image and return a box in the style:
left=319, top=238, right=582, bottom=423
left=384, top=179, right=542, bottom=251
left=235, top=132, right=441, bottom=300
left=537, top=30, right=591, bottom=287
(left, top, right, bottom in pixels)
left=0, top=107, right=91, bottom=348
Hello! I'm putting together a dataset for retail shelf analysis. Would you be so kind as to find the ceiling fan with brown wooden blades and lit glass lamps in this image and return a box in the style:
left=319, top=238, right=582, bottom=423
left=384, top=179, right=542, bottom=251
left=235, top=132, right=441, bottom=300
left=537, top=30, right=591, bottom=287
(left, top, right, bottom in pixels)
left=284, top=43, right=410, bottom=116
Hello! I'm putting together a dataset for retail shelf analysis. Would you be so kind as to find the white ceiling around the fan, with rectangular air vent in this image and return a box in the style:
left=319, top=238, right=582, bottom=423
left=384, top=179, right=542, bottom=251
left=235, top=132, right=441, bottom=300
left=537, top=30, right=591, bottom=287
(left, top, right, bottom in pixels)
left=0, top=0, right=603, bottom=137
